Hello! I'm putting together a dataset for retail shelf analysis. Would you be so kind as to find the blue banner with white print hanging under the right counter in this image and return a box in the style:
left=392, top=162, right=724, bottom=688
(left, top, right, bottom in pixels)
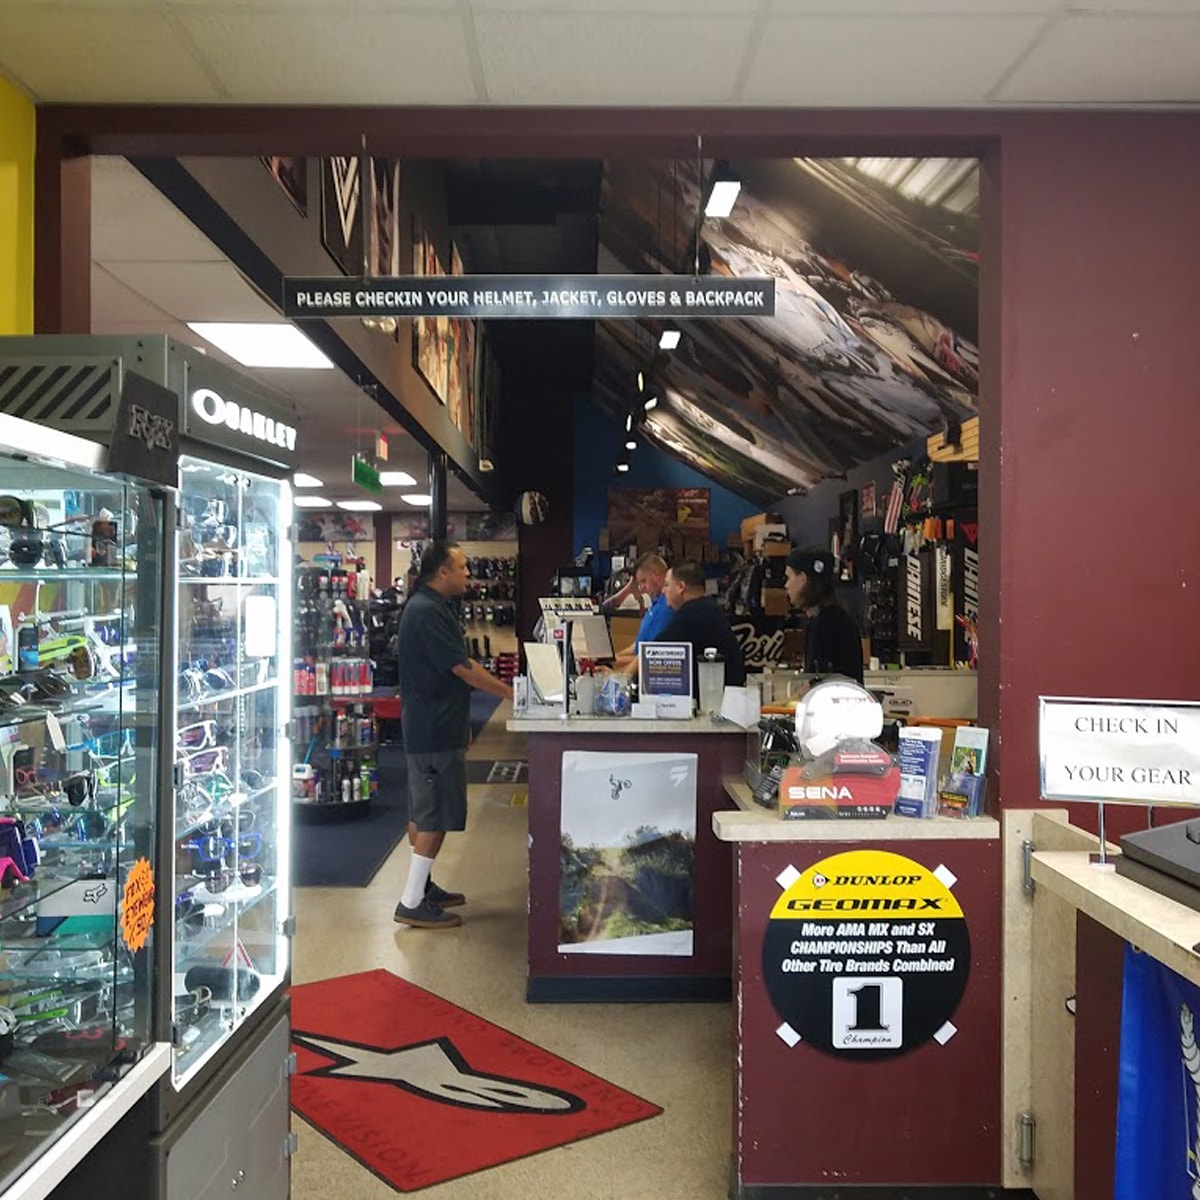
left=1112, top=947, right=1200, bottom=1200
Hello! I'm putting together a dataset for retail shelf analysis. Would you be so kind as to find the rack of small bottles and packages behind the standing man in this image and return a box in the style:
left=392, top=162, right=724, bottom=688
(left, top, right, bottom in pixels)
left=292, top=565, right=379, bottom=820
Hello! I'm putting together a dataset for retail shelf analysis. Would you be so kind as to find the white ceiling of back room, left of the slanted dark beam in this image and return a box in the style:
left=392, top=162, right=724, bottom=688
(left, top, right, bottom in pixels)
left=90, top=158, right=485, bottom=512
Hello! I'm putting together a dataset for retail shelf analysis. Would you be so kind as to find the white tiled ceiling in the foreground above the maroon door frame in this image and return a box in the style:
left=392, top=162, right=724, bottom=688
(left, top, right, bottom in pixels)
left=0, top=0, right=1200, bottom=107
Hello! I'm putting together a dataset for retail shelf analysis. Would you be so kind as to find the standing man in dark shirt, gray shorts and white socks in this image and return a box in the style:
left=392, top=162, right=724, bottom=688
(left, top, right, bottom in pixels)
left=395, top=541, right=512, bottom=929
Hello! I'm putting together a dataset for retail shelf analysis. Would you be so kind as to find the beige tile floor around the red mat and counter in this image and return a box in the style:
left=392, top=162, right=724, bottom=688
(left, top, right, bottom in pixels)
left=292, top=706, right=732, bottom=1200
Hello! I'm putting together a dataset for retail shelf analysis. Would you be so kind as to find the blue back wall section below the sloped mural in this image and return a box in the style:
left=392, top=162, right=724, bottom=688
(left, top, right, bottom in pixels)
left=575, top=396, right=762, bottom=553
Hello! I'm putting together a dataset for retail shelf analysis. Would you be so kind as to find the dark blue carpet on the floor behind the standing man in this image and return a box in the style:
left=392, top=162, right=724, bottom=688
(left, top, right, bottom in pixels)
left=292, top=691, right=499, bottom=888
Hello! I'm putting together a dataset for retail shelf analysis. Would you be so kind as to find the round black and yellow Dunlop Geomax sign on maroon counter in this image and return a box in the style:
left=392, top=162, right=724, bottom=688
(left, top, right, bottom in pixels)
left=762, top=850, right=971, bottom=1060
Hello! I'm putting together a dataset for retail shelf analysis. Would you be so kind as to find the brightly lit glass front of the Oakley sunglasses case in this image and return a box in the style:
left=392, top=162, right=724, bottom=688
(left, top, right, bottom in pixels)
left=172, top=455, right=292, bottom=1091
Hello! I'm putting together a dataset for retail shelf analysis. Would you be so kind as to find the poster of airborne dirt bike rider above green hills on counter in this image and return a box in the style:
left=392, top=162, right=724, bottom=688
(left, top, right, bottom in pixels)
left=558, top=750, right=697, bottom=958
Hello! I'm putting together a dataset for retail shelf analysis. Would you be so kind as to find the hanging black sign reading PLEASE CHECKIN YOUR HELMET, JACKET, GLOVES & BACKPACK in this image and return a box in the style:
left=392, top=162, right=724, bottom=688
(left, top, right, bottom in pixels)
left=283, top=275, right=775, bottom=320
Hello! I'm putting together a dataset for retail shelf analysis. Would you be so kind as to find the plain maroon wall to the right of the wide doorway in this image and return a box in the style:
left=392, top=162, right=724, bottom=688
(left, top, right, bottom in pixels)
left=985, top=115, right=1200, bottom=823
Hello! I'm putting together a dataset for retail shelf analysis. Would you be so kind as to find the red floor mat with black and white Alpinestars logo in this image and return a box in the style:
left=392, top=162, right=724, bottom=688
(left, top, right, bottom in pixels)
left=292, top=974, right=662, bottom=1192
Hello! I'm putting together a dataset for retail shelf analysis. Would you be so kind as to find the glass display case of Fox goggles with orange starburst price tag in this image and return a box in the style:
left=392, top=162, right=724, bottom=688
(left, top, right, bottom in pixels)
left=0, top=416, right=169, bottom=1193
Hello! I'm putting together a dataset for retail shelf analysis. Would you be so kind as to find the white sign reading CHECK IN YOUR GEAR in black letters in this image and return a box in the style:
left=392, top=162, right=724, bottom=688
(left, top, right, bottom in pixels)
left=1038, top=696, right=1200, bottom=808
